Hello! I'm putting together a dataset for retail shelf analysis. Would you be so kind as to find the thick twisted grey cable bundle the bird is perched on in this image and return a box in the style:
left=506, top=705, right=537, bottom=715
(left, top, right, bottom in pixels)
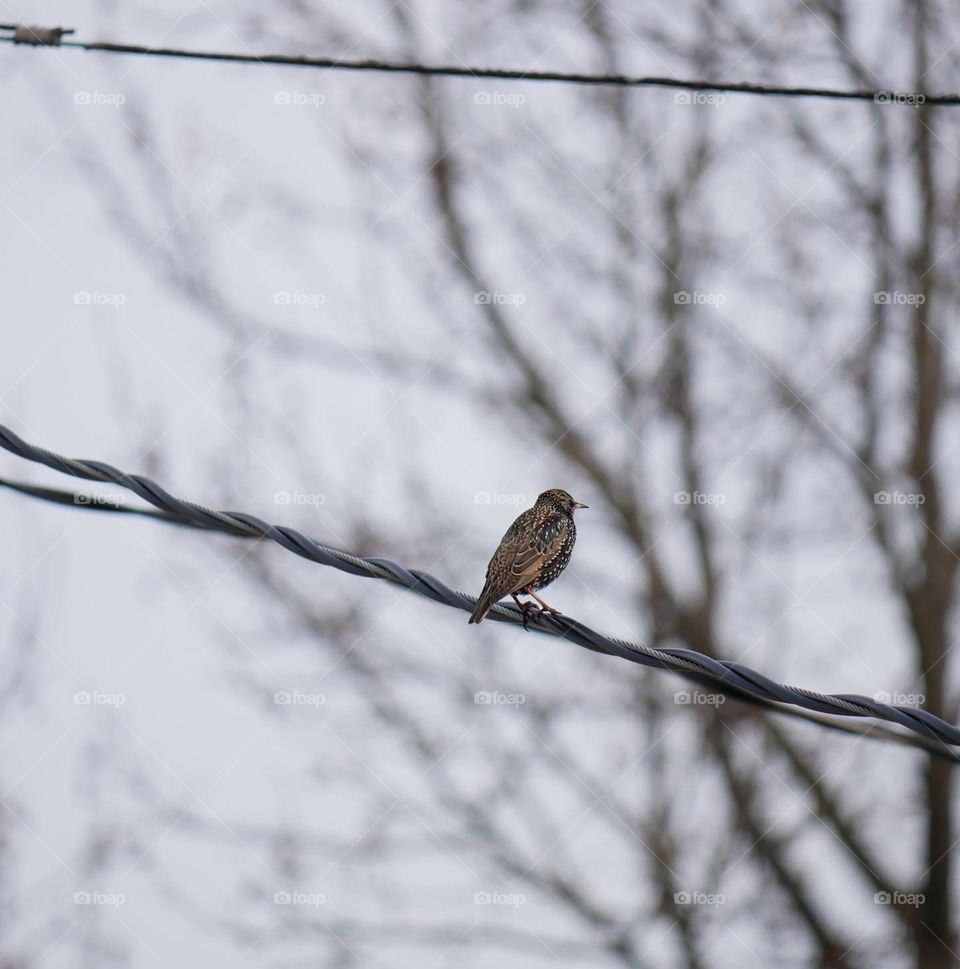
left=0, top=424, right=960, bottom=763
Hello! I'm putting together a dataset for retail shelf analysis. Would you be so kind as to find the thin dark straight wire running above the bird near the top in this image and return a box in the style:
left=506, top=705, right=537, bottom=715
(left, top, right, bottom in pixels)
left=0, top=24, right=960, bottom=107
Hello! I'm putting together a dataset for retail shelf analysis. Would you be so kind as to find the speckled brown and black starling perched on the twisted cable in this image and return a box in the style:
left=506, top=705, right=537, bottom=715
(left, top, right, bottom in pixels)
left=470, top=488, right=587, bottom=627
